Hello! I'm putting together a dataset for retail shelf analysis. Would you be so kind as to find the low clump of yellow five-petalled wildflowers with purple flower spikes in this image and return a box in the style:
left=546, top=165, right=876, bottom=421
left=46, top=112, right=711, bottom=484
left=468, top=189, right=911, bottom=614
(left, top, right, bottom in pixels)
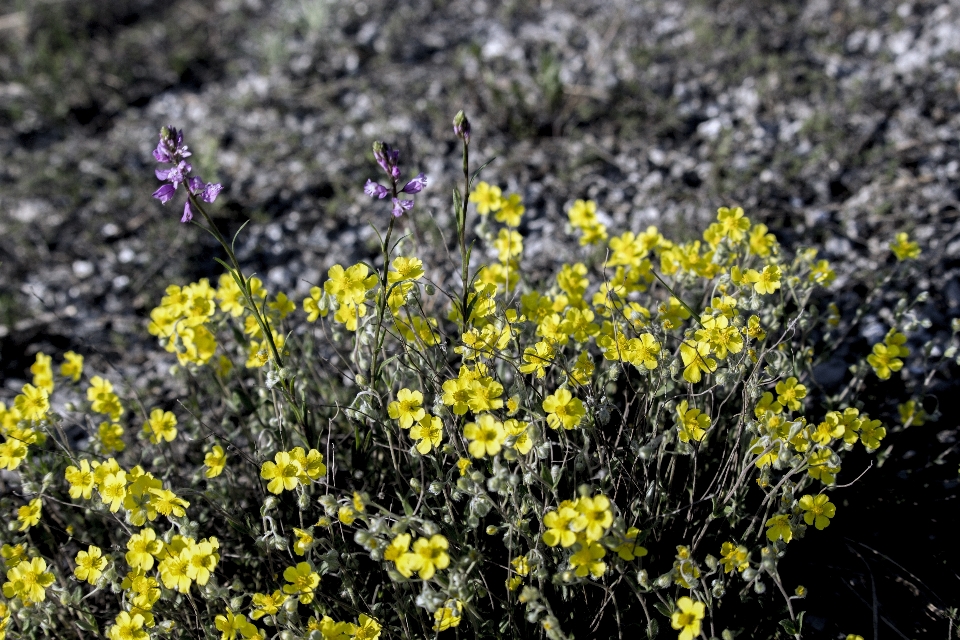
left=0, top=113, right=957, bottom=640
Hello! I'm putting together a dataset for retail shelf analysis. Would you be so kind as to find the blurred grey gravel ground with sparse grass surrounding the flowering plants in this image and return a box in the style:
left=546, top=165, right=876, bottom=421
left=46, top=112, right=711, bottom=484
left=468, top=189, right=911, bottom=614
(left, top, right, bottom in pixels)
left=0, top=0, right=960, bottom=637
